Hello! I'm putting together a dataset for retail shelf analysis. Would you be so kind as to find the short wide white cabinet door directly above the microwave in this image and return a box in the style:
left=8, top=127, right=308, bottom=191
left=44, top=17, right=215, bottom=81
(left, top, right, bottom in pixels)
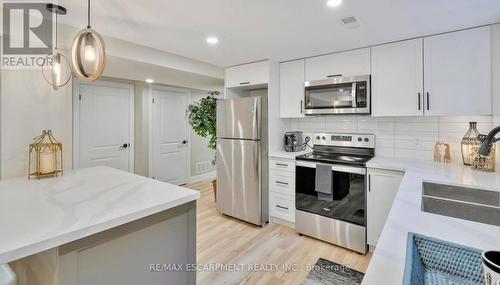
left=305, top=48, right=370, bottom=81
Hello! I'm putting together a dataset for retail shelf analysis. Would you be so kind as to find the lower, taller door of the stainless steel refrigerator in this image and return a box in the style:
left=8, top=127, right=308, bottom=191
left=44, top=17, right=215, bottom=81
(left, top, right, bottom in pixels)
left=217, top=139, right=262, bottom=225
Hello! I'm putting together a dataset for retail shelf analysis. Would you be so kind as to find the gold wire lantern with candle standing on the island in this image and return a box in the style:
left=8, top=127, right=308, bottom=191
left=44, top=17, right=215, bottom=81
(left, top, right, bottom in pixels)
left=28, top=130, right=63, bottom=179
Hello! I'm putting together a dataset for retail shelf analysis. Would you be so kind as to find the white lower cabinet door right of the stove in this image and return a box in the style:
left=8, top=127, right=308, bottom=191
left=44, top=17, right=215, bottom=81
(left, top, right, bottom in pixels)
left=367, top=169, right=403, bottom=246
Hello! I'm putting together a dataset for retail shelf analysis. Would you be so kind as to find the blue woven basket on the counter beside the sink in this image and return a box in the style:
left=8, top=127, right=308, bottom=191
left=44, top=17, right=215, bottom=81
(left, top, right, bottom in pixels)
left=403, top=233, right=484, bottom=285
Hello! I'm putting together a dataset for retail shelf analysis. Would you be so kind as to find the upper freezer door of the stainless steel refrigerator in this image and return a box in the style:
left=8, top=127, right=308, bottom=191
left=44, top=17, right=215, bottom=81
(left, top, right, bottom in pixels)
left=217, top=97, right=262, bottom=140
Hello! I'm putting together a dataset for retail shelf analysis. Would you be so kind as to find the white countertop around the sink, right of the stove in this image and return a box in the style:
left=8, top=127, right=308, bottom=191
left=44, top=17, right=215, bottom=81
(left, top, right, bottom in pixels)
left=362, top=158, right=500, bottom=285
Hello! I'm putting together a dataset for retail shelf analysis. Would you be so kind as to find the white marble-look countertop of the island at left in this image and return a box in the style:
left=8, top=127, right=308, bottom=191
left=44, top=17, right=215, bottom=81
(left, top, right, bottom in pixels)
left=0, top=166, right=200, bottom=264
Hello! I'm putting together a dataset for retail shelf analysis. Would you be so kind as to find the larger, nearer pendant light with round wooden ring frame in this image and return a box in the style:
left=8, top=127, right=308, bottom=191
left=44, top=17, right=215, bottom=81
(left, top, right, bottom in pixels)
left=71, top=0, right=106, bottom=81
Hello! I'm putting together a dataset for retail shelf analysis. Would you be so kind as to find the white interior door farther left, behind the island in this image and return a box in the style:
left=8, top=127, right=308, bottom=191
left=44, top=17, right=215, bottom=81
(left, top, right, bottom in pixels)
left=75, top=82, right=134, bottom=172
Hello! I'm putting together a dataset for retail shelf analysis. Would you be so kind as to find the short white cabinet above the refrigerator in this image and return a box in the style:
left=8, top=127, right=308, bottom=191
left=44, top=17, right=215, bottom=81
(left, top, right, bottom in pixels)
left=225, top=60, right=269, bottom=88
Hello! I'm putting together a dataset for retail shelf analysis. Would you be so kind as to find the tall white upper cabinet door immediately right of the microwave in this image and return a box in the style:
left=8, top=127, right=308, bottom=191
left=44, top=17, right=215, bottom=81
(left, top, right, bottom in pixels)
left=371, top=39, right=424, bottom=116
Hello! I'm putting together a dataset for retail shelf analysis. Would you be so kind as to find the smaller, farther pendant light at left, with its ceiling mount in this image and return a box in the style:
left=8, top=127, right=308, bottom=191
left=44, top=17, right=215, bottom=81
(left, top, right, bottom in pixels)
left=42, top=3, right=71, bottom=91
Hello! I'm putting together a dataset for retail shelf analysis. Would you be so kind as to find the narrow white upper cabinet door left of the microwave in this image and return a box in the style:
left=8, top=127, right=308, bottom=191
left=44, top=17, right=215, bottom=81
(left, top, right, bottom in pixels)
left=280, top=59, right=304, bottom=118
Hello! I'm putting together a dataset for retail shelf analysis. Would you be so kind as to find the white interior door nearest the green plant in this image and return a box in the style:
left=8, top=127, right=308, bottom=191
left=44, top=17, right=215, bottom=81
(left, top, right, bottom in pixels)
left=151, top=88, right=188, bottom=185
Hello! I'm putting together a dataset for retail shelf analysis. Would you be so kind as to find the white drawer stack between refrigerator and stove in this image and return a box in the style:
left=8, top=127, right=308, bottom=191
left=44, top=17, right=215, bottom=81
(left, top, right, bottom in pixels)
left=269, top=158, right=295, bottom=224
